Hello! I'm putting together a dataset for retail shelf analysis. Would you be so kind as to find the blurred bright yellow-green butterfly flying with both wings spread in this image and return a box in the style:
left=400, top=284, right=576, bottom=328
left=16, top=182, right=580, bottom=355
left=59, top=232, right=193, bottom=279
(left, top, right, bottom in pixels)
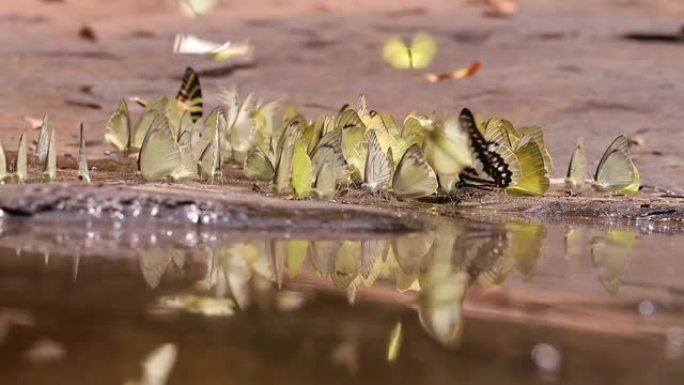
left=382, top=32, right=437, bottom=69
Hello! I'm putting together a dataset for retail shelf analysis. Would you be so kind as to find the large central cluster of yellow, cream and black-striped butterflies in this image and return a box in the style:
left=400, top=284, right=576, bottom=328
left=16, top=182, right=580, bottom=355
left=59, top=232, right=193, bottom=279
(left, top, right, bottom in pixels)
left=105, top=68, right=553, bottom=200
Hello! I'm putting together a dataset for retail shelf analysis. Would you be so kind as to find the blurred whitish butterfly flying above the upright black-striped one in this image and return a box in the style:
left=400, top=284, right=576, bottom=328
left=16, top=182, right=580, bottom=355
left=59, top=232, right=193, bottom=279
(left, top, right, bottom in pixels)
left=173, top=34, right=254, bottom=61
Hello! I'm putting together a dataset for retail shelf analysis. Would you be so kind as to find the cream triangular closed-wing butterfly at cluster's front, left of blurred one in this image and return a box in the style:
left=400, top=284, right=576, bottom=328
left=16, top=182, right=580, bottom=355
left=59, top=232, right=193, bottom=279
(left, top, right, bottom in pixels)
left=392, top=144, right=437, bottom=200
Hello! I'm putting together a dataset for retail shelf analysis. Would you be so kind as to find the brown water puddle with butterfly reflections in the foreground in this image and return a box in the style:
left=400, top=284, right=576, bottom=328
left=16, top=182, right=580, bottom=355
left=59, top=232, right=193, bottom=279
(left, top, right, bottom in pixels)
left=0, top=212, right=684, bottom=384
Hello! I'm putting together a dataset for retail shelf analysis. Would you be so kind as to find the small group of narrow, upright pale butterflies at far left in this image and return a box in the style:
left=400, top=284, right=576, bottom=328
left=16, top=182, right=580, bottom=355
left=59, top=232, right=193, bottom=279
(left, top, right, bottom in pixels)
left=0, top=115, right=90, bottom=183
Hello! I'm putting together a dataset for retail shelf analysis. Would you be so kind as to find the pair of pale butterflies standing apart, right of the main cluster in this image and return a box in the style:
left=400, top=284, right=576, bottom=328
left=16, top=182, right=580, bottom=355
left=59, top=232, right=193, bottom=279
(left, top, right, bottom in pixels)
left=565, top=135, right=641, bottom=195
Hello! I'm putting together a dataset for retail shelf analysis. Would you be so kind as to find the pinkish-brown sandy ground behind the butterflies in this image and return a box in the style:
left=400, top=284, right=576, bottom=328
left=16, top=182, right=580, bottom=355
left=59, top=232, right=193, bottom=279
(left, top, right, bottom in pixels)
left=0, top=0, right=684, bottom=191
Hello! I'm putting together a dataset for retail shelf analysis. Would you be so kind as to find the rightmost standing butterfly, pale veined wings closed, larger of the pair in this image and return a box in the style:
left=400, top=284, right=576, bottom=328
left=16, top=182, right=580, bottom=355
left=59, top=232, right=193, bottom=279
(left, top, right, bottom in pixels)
left=594, top=135, right=639, bottom=194
